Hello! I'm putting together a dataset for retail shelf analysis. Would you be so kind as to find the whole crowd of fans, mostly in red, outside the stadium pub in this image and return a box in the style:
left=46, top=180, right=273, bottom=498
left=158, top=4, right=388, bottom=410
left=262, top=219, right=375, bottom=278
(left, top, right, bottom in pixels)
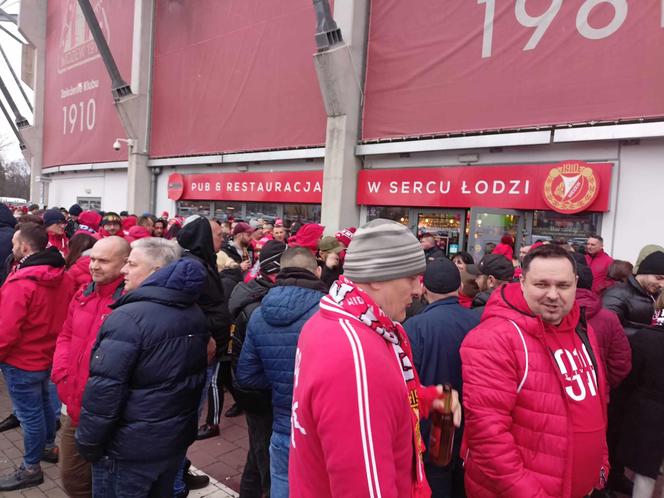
left=0, top=200, right=664, bottom=498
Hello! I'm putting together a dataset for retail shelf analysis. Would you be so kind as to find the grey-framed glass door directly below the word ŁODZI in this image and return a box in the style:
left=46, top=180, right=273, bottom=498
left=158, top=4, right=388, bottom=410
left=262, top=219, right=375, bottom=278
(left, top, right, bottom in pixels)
left=468, top=208, right=532, bottom=262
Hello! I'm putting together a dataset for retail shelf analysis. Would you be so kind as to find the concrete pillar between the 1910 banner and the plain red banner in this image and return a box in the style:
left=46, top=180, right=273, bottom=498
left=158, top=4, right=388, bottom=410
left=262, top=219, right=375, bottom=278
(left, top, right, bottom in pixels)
left=115, top=0, right=155, bottom=214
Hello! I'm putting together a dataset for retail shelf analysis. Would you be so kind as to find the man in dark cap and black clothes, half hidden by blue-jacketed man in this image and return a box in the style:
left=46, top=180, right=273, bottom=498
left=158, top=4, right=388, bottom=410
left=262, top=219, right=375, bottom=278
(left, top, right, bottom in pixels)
left=228, top=240, right=288, bottom=498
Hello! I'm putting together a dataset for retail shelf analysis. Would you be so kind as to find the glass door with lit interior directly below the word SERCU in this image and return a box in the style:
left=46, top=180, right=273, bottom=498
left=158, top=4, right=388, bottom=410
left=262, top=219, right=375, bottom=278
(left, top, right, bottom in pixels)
left=410, top=208, right=466, bottom=256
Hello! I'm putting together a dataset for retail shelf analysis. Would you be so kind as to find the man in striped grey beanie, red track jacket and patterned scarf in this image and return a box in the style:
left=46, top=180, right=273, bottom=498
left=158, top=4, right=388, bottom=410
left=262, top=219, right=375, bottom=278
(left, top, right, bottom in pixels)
left=289, top=219, right=461, bottom=498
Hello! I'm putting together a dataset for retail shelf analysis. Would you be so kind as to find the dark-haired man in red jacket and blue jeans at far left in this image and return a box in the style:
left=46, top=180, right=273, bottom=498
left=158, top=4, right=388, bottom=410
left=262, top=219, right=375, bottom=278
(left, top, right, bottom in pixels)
left=0, top=223, right=73, bottom=491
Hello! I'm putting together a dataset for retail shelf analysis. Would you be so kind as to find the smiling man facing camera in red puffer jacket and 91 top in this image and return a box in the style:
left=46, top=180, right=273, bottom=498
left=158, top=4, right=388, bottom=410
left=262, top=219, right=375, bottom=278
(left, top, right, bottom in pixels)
left=461, top=245, right=608, bottom=498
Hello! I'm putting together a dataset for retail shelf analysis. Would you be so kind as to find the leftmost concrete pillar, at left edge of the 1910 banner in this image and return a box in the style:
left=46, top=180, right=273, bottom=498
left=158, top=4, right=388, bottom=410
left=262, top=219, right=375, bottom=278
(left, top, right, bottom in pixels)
left=18, top=0, right=48, bottom=203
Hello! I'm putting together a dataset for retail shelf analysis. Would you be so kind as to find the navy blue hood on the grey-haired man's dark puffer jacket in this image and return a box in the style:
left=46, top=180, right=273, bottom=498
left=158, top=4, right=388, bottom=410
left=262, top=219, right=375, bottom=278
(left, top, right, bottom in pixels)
left=111, top=258, right=207, bottom=308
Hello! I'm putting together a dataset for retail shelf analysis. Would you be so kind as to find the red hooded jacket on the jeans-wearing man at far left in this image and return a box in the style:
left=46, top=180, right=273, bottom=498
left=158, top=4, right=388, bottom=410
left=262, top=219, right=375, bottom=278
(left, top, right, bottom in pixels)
left=0, top=247, right=74, bottom=371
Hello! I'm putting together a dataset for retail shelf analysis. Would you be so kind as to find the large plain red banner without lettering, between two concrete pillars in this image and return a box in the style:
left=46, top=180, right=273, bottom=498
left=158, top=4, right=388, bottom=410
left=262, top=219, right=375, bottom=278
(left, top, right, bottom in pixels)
left=150, top=0, right=326, bottom=157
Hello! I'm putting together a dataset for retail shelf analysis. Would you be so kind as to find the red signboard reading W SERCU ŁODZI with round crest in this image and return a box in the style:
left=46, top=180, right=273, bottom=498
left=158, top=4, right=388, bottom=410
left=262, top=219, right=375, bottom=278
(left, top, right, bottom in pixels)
left=357, top=161, right=612, bottom=213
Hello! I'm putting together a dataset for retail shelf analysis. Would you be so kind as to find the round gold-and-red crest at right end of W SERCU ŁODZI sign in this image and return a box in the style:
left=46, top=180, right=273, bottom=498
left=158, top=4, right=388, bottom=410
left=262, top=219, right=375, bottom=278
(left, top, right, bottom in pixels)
left=544, top=161, right=599, bottom=214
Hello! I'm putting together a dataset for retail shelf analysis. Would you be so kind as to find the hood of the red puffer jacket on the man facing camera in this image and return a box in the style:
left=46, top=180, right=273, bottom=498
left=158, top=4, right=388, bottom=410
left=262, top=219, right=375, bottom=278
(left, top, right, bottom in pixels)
left=481, top=282, right=581, bottom=336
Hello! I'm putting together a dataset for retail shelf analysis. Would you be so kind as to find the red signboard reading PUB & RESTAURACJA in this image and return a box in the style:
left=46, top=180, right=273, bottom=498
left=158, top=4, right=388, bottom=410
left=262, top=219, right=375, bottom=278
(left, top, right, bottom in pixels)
left=168, top=171, right=323, bottom=204
